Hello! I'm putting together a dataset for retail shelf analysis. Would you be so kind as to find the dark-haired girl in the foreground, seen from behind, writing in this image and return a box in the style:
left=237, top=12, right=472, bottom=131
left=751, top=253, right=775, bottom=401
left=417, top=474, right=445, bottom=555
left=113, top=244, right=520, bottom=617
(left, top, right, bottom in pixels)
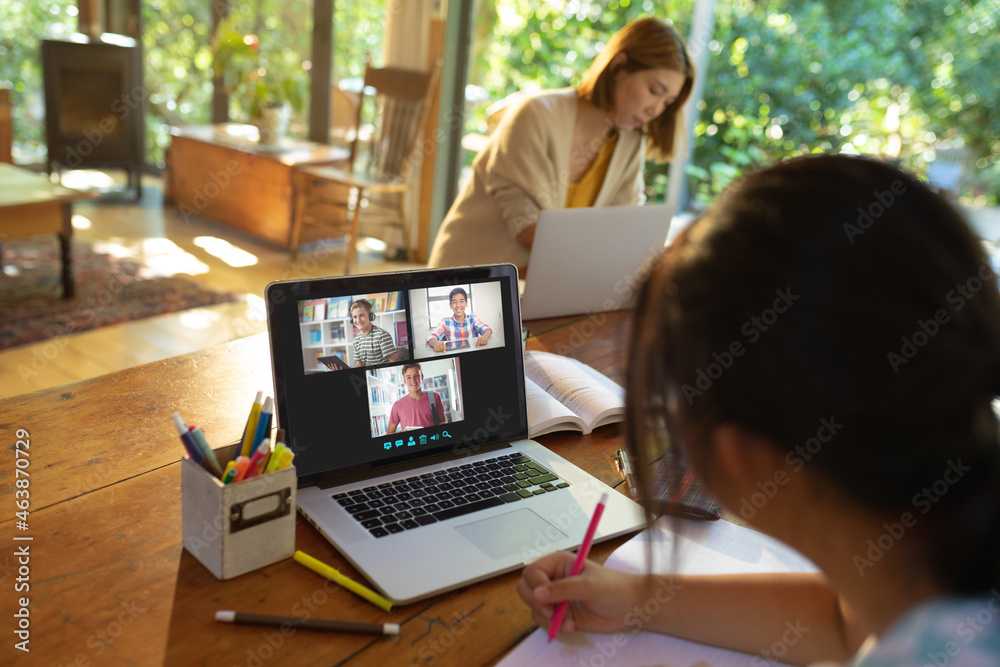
left=518, top=155, right=1000, bottom=667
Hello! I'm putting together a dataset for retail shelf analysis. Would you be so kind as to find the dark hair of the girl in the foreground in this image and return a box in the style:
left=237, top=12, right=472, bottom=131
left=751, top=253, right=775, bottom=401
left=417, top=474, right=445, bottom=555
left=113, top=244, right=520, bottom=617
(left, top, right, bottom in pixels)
left=627, top=155, right=1000, bottom=593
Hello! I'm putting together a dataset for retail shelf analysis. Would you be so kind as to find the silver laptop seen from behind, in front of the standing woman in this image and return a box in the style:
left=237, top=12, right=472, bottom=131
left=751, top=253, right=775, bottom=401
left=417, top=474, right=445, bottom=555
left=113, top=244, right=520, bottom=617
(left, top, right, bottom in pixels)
left=521, top=204, right=674, bottom=320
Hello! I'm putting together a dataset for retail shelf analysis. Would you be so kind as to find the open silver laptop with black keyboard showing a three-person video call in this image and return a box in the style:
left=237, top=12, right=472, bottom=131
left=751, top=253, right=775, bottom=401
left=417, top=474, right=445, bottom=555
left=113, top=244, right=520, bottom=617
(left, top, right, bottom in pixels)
left=266, top=265, right=643, bottom=603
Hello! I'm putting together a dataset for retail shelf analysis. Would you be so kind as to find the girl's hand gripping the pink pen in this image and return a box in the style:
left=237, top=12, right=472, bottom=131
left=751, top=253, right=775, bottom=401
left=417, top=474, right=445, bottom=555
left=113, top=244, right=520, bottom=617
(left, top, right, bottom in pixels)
left=517, top=551, right=643, bottom=632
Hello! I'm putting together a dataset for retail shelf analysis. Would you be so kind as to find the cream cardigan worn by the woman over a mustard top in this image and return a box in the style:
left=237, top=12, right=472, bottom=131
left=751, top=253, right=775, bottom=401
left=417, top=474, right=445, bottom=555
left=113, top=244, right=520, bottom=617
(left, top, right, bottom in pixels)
left=428, top=88, right=645, bottom=275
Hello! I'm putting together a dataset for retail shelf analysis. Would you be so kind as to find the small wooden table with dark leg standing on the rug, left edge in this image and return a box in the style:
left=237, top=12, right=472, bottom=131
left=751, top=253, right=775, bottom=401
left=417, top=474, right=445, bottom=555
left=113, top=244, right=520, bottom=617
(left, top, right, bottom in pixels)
left=0, top=163, right=94, bottom=298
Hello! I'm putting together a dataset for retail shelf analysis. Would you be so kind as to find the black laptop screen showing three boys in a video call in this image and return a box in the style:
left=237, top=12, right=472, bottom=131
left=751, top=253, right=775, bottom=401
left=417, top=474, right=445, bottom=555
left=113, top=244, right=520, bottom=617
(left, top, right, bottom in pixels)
left=266, top=265, right=528, bottom=485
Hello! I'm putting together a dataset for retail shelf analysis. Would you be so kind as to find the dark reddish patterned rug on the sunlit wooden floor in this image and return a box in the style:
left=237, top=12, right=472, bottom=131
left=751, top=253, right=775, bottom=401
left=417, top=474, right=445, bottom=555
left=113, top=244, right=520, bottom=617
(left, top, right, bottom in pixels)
left=0, top=236, right=242, bottom=350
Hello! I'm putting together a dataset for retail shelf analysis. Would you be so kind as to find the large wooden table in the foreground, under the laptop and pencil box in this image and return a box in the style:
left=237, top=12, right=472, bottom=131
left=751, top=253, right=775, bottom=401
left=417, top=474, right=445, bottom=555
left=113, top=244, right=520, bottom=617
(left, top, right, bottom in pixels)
left=0, top=313, right=628, bottom=666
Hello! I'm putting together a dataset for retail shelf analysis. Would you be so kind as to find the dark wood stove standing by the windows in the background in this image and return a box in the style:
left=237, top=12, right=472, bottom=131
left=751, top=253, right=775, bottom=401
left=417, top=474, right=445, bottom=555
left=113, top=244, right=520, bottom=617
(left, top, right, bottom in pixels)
left=42, top=33, right=146, bottom=197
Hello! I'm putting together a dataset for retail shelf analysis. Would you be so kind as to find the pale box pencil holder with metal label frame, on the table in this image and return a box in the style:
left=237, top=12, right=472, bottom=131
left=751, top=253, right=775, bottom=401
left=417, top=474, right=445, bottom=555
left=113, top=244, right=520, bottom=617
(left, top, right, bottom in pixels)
left=181, top=445, right=297, bottom=579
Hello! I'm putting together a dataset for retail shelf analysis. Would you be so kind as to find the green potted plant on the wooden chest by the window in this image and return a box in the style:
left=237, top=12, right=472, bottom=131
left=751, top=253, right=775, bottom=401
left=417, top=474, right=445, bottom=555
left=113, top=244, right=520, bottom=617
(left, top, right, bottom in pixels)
left=212, top=14, right=305, bottom=144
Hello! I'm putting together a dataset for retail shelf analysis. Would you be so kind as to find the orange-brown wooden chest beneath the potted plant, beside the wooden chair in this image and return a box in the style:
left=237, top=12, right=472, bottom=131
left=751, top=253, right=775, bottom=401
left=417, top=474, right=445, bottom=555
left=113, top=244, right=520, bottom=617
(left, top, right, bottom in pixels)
left=164, top=124, right=348, bottom=248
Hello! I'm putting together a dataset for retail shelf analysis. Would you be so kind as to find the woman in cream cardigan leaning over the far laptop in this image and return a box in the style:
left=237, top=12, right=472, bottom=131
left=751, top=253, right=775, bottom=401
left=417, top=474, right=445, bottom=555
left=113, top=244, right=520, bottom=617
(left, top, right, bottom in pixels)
left=428, top=18, right=694, bottom=273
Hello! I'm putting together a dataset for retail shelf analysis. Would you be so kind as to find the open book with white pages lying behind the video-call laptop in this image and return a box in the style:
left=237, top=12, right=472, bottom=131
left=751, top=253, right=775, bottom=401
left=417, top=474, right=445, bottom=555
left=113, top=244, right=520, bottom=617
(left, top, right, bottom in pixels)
left=524, top=350, right=625, bottom=438
